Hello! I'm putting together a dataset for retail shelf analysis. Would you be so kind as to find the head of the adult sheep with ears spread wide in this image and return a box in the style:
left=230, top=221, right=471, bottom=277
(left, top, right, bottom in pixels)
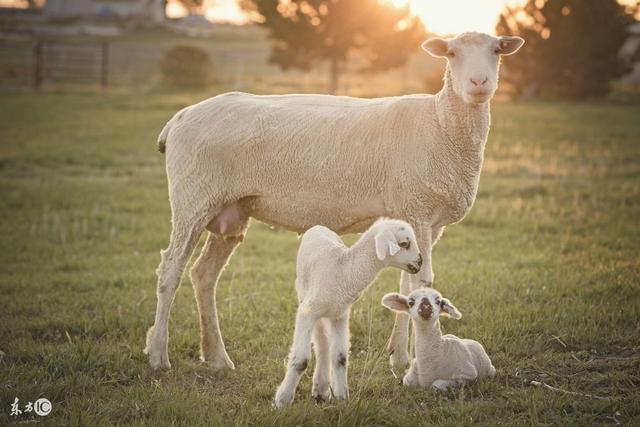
left=422, top=33, right=524, bottom=104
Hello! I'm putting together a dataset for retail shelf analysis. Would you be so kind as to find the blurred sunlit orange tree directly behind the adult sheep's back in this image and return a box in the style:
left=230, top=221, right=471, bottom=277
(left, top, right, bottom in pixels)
left=240, top=0, right=424, bottom=93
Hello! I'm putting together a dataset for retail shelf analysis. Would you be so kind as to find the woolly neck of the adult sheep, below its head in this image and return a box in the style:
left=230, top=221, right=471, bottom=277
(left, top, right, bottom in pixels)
left=436, top=65, right=491, bottom=154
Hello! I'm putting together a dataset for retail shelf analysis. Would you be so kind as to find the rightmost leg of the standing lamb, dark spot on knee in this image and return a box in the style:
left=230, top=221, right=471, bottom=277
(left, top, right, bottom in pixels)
left=331, top=311, right=349, bottom=400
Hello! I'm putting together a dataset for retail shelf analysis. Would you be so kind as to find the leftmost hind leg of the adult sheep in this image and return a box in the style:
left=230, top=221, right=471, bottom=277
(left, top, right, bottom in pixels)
left=144, top=221, right=204, bottom=369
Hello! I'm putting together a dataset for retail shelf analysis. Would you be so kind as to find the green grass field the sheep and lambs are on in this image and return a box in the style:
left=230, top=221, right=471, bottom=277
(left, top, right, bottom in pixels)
left=0, top=93, right=640, bottom=425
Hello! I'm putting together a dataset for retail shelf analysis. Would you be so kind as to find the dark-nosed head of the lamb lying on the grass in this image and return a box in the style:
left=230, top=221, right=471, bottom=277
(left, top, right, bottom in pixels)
left=382, top=288, right=462, bottom=321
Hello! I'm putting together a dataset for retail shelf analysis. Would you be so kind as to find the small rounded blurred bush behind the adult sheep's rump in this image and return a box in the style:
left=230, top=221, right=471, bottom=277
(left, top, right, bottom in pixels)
left=162, top=45, right=213, bottom=88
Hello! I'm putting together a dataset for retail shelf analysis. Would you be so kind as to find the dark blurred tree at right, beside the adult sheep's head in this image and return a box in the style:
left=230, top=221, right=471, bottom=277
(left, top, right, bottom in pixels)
left=496, top=0, right=638, bottom=98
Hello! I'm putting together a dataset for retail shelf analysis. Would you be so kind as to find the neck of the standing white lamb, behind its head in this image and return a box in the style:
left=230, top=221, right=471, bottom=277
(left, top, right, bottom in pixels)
left=345, top=229, right=384, bottom=300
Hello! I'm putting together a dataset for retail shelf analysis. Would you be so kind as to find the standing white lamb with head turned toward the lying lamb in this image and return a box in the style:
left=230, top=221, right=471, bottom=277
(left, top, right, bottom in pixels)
left=275, top=219, right=422, bottom=408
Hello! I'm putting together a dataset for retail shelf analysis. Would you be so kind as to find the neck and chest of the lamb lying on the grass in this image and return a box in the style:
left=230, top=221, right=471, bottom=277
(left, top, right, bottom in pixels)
left=413, top=319, right=444, bottom=385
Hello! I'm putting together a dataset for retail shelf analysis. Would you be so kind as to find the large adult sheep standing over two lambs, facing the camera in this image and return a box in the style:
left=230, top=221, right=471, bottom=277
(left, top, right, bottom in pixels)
left=145, top=33, right=524, bottom=369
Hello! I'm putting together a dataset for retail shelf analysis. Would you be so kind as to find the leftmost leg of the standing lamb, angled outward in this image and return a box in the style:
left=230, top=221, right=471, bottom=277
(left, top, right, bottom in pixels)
left=274, top=304, right=316, bottom=409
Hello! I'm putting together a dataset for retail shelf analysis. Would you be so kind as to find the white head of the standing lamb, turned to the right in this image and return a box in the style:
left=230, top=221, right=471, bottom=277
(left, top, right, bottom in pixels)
left=372, top=219, right=422, bottom=274
